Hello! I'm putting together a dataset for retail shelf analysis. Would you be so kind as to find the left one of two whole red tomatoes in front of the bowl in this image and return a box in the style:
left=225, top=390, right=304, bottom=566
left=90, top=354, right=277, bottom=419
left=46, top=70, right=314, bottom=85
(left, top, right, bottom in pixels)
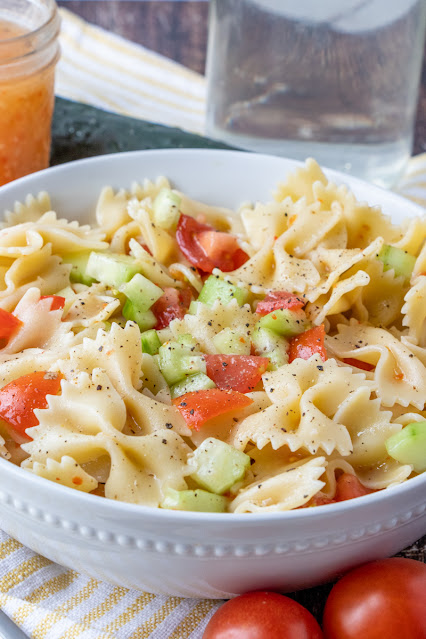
left=203, top=592, right=323, bottom=639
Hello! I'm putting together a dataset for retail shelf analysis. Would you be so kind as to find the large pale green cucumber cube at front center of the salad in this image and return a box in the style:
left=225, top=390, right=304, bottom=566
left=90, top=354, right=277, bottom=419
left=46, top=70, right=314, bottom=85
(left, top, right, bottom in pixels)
left=188, top=437, right=250, bottom=495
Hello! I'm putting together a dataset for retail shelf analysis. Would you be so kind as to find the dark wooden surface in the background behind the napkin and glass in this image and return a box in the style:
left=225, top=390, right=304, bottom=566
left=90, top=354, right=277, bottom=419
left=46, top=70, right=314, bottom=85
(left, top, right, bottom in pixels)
left=58, top=0, right=426, bottom=154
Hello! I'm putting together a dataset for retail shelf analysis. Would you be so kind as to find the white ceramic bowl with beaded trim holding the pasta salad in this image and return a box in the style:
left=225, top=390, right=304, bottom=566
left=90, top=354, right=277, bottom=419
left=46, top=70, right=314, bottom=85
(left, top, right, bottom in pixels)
left=0, top=150, right=426, bottom=598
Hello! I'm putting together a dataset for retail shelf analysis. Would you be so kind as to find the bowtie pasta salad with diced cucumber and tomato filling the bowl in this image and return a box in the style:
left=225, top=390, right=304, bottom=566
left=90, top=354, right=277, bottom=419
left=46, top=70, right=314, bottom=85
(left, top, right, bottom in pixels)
left=0, top=160, right=426, bottom=513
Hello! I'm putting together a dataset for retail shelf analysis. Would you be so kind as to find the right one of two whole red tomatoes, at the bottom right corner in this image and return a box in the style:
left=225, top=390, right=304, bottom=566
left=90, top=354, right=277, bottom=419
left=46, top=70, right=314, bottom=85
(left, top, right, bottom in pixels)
left=323, top=557, right=426, bottom=639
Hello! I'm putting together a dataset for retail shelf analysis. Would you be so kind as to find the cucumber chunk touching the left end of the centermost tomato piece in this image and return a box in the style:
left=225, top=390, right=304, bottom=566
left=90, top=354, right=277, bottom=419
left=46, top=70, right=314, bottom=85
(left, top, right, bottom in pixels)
left=158, top=342, right=206, bottom=386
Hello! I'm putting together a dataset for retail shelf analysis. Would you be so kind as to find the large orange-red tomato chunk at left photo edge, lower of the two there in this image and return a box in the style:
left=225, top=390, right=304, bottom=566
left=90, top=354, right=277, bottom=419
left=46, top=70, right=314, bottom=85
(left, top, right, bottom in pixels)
left=0, top=371, right=62, bottom=441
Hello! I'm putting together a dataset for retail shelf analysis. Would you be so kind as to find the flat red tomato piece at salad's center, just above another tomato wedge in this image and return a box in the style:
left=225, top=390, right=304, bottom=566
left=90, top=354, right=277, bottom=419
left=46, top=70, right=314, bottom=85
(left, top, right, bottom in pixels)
left=205, top=355, right=269, bottom=393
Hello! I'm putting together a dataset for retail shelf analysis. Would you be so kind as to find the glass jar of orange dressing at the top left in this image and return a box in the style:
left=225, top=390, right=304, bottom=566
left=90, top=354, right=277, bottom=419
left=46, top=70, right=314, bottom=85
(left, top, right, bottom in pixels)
left=0, top=0, right=60, bottom=185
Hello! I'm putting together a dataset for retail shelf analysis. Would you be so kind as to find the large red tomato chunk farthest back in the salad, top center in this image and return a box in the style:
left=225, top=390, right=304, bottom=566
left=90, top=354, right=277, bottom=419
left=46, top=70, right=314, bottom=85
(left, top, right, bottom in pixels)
left=176, top=214, right=248, bottom=273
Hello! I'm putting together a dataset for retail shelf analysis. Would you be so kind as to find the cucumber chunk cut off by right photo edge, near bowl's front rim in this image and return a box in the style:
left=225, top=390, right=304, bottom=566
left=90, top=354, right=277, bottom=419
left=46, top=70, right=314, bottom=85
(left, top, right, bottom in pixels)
left=386, top=420, right=426, bottom=473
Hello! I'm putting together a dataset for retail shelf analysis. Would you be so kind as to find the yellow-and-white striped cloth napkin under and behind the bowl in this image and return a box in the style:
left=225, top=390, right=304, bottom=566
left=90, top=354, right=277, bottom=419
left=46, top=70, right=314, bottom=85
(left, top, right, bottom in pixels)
left=0, top=9, right=426, bottom=639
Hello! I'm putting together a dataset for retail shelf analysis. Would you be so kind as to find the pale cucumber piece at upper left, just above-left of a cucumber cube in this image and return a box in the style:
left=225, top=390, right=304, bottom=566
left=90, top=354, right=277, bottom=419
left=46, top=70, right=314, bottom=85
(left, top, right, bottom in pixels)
left=86, top=251, right=141, bottom=288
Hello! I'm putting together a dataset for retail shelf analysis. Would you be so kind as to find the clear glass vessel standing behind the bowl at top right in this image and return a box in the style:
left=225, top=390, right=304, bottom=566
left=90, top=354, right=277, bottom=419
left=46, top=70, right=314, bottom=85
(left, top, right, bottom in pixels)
left=207, top=0, right=426, bottom=186
